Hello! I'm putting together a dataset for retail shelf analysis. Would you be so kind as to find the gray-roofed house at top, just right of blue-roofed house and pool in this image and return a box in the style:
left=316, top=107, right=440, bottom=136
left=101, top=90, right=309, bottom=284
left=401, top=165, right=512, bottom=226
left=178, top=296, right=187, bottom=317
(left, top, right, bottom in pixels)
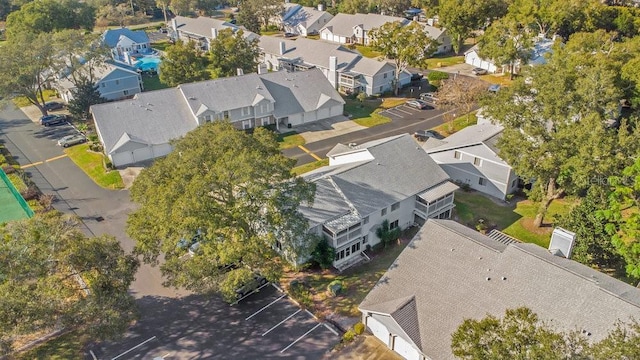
left=168, top=16, right=259, bottom=51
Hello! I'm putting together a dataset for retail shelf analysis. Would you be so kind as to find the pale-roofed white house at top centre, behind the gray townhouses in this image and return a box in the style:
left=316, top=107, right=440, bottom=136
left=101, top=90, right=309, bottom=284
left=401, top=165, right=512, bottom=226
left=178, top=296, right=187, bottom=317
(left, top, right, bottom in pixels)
left=320, top=13, right=411, bottom=45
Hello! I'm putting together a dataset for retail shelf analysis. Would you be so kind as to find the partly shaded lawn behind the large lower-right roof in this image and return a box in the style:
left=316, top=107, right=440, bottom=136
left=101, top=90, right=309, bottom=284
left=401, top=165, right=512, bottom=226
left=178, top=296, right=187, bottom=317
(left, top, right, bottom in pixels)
left=455, top=191, right=575, bottom=248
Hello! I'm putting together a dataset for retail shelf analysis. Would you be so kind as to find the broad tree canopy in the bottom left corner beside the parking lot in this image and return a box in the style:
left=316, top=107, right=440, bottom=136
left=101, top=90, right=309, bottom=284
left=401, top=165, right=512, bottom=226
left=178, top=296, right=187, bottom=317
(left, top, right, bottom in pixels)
left=0, top=212, right=139, bottom=353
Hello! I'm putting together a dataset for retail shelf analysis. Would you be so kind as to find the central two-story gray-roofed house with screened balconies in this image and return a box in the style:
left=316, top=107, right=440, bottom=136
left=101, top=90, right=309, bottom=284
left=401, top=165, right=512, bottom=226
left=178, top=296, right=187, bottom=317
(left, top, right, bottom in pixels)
left=300, top=134, right=458, bottom=269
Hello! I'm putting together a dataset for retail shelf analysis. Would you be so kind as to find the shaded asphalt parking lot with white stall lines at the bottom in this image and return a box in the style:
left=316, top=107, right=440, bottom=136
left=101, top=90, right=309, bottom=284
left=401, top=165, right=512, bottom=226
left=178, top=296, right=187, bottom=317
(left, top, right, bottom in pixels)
left=86, top=284, right=340, bottom=360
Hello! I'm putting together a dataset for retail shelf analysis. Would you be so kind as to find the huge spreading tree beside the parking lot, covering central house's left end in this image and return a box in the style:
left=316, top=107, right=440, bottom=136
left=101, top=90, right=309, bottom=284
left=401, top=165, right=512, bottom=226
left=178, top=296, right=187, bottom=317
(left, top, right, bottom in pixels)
left=127, top=121, right=315, bottom=300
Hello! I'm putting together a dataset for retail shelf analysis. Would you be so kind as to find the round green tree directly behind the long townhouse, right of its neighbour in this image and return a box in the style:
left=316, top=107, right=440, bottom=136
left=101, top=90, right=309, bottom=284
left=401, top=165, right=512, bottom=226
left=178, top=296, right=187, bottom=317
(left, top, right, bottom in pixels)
left=209, top=29, right=260, bottom=77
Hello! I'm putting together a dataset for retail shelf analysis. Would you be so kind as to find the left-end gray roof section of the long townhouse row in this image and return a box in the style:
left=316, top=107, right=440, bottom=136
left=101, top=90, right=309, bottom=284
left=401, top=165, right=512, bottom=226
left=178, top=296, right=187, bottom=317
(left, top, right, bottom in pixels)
left=91, top=88, right=197, bottom=153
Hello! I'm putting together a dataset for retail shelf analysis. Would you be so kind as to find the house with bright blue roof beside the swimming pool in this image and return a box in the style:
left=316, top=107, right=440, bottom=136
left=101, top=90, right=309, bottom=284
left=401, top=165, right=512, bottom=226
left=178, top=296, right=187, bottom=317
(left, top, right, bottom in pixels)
left=102, top=27, right=152, bottom=62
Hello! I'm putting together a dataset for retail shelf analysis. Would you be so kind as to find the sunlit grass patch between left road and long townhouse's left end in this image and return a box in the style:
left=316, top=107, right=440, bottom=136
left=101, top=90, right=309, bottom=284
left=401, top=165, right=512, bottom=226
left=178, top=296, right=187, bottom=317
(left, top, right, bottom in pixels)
left=64, top=144, right=124, bottom=189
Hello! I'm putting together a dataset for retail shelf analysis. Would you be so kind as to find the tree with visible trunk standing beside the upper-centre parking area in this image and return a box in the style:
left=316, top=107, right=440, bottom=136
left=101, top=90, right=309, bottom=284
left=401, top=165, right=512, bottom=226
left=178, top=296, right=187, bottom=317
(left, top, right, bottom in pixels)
left=370, top=22, right=439, bottom=94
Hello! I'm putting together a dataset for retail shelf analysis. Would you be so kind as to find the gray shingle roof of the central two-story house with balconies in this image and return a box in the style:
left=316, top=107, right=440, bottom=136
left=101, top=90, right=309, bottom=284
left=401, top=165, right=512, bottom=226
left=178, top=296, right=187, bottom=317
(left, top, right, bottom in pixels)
left=301, top=134, right=449, bottom=222
